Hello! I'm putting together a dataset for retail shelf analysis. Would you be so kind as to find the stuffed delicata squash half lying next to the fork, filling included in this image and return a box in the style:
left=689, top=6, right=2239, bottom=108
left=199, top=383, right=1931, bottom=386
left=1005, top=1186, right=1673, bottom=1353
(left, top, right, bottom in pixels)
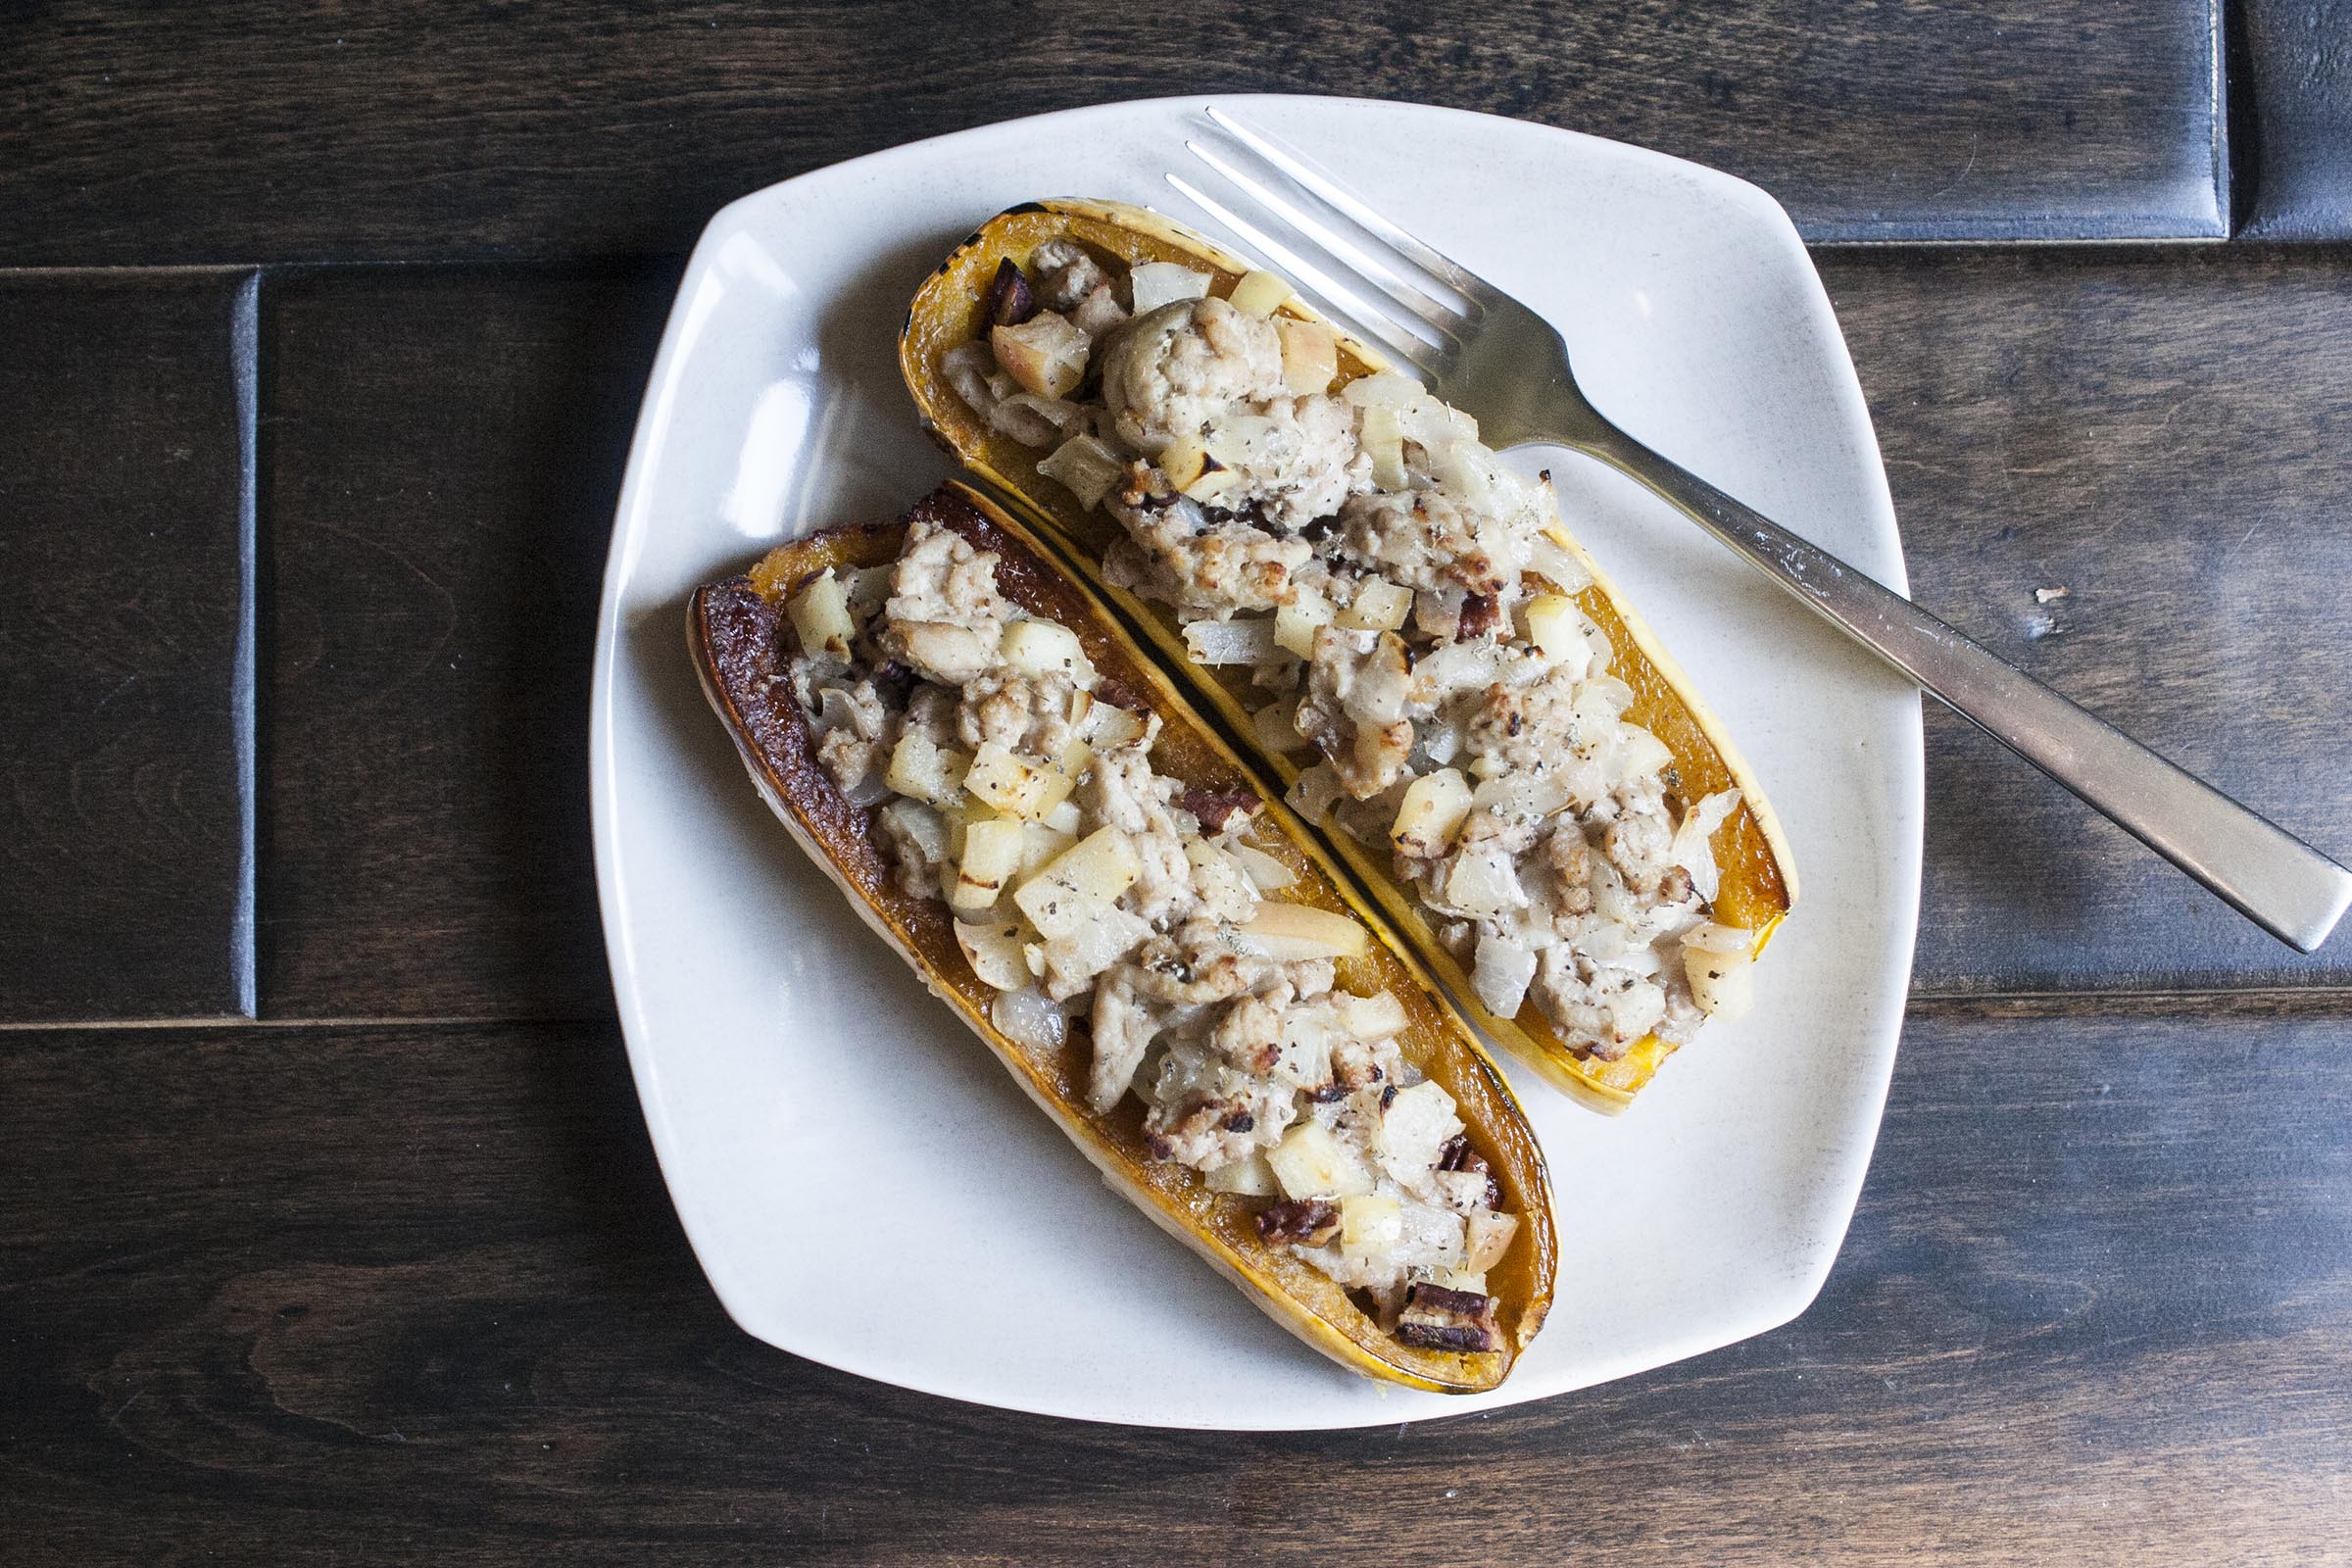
left=901, top=200, right=1797, bottom=1112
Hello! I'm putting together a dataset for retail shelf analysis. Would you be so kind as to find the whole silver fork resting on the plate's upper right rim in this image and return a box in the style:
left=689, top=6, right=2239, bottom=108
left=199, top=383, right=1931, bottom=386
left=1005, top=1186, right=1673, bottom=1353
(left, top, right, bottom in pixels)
left=1166, top=108, right=2352, bottom=953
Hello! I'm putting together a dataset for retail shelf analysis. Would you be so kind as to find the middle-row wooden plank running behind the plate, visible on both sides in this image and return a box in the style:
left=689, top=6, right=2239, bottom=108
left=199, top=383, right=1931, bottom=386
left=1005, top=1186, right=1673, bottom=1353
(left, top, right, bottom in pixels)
left=264, top=252, right=2352, bottom=1018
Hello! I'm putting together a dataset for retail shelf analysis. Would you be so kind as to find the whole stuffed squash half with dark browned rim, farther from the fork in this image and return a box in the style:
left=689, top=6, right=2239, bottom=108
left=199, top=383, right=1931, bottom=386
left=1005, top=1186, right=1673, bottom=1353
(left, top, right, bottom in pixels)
left=689, top=487, right=1554, bottom=1392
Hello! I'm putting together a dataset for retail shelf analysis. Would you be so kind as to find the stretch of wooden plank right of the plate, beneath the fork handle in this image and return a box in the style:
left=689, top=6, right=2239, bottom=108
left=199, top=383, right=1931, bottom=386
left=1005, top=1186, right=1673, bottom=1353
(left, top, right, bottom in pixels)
left=1823, top=252, right=2352, bottom=995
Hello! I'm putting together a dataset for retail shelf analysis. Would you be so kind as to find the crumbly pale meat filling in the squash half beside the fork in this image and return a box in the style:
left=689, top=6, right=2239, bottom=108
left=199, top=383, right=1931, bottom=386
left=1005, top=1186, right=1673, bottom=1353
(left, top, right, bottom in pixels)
left=941, top=240, right=1752, bottom=1060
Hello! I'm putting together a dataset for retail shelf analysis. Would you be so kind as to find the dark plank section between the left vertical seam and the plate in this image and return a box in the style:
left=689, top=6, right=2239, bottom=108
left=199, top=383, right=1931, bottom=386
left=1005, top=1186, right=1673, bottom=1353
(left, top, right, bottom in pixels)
left=261, top=270, right=675, bottom=1018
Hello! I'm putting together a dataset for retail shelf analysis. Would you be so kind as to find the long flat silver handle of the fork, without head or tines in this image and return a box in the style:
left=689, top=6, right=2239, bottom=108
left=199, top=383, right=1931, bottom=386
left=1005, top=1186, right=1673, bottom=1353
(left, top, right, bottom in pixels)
left=1569, top=420, right=2352, bottom=953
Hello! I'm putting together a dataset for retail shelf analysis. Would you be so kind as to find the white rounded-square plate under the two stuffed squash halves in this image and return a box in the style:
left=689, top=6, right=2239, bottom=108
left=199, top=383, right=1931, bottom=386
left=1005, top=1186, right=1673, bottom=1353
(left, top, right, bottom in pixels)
left=590, top=99, right=1922, bottom=1429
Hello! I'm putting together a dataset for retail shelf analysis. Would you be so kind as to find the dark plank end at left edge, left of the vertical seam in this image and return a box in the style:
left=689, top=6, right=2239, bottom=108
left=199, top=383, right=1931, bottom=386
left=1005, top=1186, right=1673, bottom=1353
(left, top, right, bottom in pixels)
left=0, top=272, right=252, bottom=1022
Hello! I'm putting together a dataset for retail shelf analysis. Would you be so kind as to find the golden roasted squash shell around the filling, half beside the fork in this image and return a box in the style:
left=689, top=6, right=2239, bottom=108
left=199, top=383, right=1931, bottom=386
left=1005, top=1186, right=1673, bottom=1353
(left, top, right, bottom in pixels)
left=899, top=200, right=1797, bottom=1114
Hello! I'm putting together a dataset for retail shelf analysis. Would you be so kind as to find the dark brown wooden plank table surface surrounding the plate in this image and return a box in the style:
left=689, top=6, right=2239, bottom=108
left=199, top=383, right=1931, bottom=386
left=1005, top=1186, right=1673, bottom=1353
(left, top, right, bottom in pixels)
left=0, top=0, right=2352, bottom=1568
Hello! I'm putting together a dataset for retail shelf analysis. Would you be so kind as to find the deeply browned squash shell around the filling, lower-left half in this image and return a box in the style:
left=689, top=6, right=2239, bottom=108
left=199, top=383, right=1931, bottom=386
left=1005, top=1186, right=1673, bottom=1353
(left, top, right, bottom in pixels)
left=687, top=484, right=1557, bottom=1394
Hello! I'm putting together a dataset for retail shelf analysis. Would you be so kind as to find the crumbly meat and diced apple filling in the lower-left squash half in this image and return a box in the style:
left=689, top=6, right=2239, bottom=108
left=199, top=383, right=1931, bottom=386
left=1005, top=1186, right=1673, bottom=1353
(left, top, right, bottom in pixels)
left=786, top=516, right=1519, bottom=1351
